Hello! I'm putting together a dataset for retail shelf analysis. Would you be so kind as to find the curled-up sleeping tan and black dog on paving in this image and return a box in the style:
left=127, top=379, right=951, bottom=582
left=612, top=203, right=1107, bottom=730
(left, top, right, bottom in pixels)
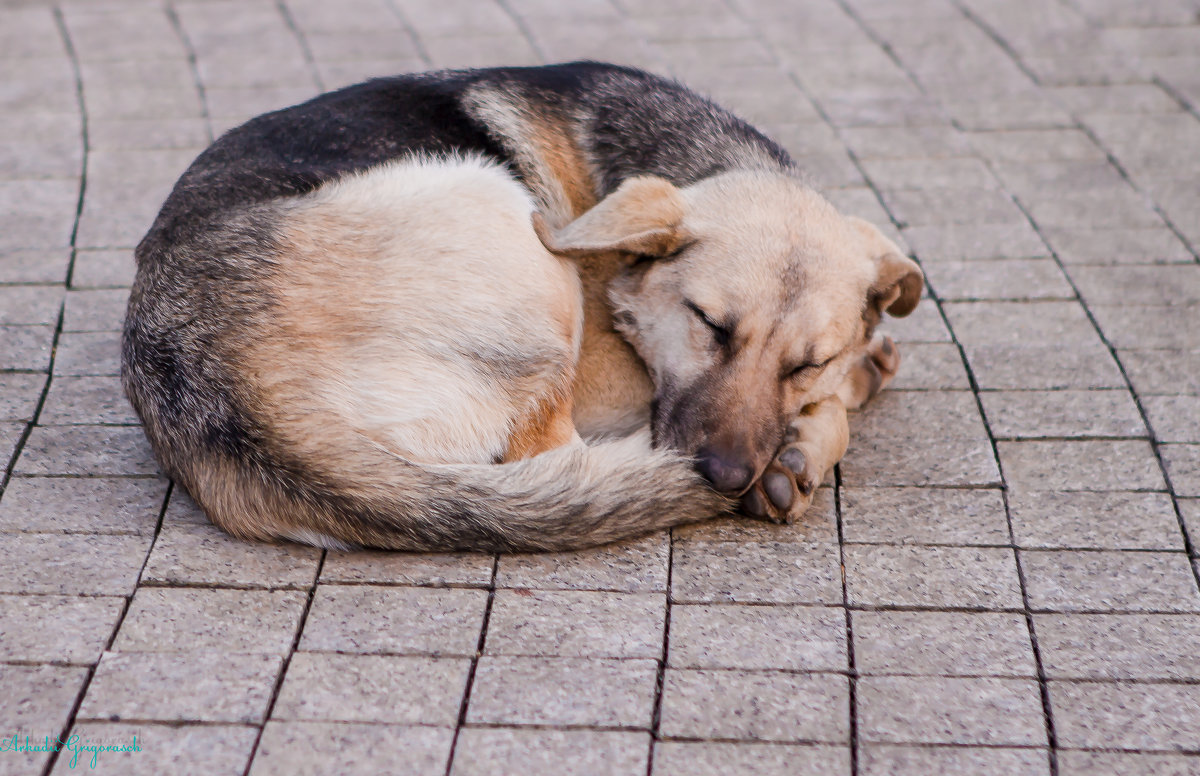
left=122, top=62, right=923, bottom=552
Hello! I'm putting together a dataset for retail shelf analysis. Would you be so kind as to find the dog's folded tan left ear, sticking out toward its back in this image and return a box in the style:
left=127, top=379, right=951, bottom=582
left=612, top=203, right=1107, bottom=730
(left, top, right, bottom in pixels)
left=533, top=175, right=690, bottom=257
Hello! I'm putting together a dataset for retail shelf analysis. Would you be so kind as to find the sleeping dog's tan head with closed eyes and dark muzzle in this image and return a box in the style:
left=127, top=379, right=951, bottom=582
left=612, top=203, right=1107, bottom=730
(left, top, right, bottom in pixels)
left=535, top=172, right=923, bottom=493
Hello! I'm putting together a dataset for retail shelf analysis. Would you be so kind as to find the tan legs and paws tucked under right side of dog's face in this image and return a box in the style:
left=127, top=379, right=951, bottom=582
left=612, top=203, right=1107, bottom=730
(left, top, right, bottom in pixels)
left=742, top=335, right=900, bottom=523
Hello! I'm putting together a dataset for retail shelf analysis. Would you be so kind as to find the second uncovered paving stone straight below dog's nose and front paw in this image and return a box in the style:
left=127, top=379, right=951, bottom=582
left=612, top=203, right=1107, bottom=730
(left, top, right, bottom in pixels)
left=667, top=604, right=847, bottom=670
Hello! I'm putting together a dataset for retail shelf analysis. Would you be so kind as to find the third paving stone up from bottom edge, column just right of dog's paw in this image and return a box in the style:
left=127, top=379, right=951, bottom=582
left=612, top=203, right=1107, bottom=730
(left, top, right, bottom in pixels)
left=852, top=612, right=1036, bottom=676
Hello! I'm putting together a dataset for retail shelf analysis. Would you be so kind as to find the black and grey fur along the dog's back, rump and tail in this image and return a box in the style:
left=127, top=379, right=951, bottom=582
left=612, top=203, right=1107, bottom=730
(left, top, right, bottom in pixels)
left=122, top=62, right=791, bottom=549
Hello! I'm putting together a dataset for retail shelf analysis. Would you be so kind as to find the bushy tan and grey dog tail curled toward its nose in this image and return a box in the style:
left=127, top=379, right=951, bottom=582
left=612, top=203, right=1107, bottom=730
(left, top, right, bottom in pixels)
left=199, top=433, right=732, bottom=552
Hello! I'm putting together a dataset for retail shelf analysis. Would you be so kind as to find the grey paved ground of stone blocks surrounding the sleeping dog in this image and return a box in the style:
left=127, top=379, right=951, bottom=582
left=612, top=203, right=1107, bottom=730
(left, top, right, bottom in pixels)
left=0, top=0, right=1200, bottom=776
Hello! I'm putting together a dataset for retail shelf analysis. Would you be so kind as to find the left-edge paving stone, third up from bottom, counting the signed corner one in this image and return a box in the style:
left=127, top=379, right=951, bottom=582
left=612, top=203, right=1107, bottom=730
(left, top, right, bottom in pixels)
left=0, top=595, right=125, bottom=664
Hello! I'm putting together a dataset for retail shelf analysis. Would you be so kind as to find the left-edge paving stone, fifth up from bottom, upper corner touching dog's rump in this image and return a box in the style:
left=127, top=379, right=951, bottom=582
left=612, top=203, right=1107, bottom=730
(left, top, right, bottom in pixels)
left=0, top=477, right=167, bottom=535
